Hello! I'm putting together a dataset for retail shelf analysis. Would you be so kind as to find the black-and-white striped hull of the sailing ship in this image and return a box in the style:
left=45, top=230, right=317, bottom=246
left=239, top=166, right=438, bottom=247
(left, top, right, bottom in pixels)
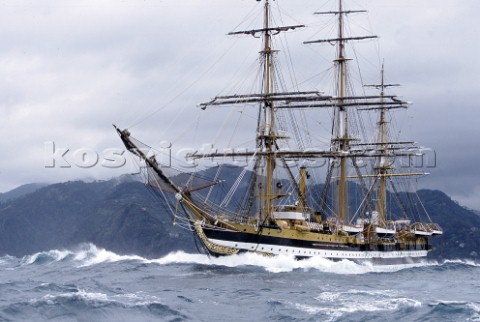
left=197, top=226, right=430, bottom=265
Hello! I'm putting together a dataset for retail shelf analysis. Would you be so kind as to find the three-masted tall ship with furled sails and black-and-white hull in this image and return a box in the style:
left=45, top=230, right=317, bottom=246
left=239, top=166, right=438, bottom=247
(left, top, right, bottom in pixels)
left=115, top=0, right=443, bottom=263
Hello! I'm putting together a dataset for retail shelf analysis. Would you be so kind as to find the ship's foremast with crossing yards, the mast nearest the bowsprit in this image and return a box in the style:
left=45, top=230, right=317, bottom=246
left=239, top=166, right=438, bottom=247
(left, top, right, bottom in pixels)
left=199, top=0, right=312, bottom=225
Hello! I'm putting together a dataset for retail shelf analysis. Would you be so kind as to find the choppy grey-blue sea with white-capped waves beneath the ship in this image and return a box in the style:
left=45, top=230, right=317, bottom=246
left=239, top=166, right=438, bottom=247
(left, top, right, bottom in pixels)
left=0, top=244, right=480, bottom=322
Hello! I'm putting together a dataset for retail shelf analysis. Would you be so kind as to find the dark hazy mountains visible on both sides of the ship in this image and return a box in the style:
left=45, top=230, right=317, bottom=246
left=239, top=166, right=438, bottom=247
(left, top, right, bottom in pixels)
left=0, top=176, right=480, bottom=260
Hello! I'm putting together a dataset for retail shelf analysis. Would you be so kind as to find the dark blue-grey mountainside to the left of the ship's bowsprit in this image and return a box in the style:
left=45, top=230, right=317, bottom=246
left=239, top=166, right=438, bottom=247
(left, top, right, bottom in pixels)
left=0, top=180, right=195, bottom=257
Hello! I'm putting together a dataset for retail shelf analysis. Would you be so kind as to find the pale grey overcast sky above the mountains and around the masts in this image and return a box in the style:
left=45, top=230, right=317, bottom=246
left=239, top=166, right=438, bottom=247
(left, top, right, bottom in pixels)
left=0, top=0, right=480, bottom=209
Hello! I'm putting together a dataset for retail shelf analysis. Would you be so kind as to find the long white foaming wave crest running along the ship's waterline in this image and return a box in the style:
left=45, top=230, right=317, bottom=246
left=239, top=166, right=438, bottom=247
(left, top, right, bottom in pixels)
left=7, top=244, right=480, bottom=275
